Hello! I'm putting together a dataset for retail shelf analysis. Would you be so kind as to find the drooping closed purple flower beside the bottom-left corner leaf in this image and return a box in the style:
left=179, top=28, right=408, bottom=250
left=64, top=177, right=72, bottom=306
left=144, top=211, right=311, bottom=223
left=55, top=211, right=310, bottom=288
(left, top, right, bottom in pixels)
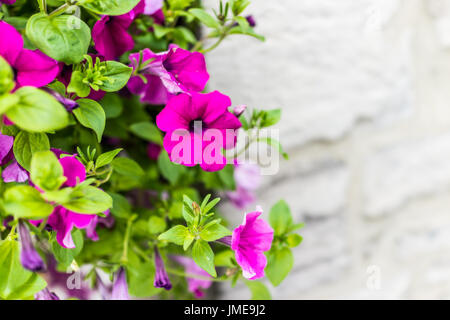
left=19, top=221, right=45, bottom=272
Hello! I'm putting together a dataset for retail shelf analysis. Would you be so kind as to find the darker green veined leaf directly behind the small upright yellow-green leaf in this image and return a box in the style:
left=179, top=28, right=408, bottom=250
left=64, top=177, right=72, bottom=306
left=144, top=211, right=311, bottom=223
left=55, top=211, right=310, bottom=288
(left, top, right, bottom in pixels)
left=13, top=131, right=50, bottom=171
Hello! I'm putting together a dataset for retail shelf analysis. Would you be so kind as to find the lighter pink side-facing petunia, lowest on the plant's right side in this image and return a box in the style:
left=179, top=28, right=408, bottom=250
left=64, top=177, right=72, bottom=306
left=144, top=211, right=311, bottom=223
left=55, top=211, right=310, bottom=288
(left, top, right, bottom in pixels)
left=231, top=209, right=273, bottom=280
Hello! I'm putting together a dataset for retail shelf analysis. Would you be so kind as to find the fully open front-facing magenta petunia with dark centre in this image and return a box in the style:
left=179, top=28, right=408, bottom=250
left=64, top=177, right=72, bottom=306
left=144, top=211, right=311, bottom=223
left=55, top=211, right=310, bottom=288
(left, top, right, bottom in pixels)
left=156, top=91, right=241, bottom=171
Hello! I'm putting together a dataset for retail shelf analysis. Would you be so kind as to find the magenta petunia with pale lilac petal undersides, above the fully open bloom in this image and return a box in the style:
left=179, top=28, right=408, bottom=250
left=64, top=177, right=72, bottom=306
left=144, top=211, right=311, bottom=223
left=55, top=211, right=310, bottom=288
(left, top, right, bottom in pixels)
left=128, top=44, right=209, bottom=104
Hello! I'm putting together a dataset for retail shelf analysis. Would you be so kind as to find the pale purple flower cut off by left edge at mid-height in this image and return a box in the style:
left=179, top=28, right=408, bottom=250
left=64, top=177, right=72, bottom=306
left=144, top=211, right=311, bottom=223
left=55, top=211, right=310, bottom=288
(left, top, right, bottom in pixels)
left=0, top=134, right=28, bottom=182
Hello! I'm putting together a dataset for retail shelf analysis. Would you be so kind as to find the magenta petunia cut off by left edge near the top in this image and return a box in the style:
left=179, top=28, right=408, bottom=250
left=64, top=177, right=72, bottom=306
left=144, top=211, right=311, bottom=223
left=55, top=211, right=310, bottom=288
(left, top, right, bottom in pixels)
left=0, top=21, right=60, bottom=87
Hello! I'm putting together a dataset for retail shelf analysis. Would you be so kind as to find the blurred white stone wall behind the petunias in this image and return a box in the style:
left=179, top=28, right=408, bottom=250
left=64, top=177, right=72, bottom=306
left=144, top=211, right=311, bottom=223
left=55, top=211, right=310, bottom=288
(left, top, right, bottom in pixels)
left=205, top=0, right=450, bottom=299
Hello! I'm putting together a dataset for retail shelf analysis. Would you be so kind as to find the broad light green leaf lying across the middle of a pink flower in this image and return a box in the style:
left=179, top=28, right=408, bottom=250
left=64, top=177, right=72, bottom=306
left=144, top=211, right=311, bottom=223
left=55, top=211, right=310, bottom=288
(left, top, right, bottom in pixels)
left=62, top=184, right=113, bottom=214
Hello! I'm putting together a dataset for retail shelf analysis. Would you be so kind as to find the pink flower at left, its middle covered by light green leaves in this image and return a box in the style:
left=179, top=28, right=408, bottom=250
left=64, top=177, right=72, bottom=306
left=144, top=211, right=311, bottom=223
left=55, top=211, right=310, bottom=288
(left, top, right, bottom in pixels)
left=32, top=156, right=97, bottom=248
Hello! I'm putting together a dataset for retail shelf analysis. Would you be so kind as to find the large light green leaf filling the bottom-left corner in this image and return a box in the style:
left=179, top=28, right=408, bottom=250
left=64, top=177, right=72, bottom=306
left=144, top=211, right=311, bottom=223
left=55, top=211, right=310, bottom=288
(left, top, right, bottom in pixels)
left=0, top=239, right=47, bottom=300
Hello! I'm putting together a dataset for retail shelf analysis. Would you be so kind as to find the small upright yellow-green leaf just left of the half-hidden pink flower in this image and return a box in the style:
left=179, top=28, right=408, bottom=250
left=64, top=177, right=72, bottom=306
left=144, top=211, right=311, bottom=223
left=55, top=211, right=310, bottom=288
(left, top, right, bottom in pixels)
left=30, top=150, right=67, bottom=191
